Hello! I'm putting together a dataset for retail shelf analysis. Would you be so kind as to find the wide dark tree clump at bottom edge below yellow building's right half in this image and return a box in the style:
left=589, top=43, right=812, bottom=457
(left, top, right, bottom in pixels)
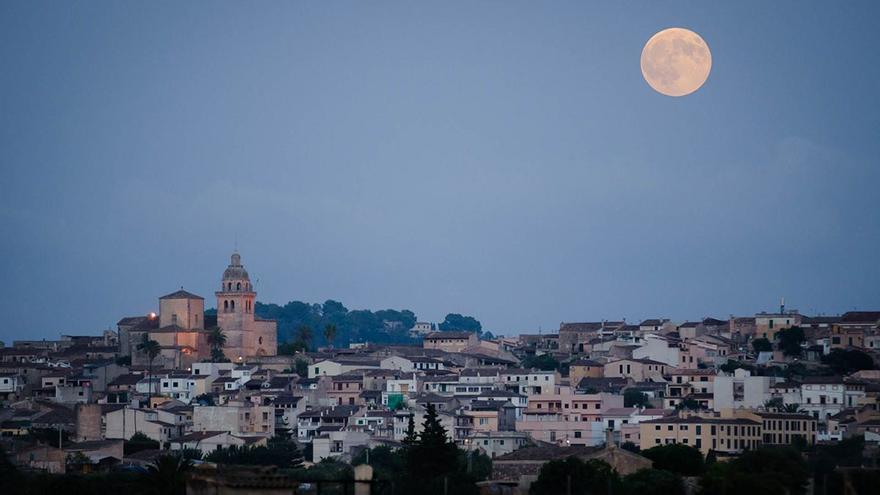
left=700, top=447, right=809, bottom=495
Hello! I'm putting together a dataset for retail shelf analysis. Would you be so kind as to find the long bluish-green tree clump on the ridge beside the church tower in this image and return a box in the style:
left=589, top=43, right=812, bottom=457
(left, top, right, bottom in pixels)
left=254, top=300, right=416, bottom=347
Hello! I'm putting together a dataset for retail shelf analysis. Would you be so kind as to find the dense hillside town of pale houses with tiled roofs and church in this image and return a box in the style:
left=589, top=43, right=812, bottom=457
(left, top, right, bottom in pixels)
left=0, top=253, right=880, bottom=493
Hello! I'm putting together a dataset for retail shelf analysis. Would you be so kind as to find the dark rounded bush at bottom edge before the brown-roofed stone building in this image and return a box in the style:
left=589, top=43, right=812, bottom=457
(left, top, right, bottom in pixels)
left=529, top=456, right=621, bottom=495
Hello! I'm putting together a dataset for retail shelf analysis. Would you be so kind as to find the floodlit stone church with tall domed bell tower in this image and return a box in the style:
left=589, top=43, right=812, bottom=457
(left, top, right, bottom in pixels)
left=117, top=252, right=278, bottom=369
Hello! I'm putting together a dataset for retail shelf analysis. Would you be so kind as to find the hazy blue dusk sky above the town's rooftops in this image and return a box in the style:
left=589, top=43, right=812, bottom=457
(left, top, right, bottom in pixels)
left=0, top=0, right=880, bottom=344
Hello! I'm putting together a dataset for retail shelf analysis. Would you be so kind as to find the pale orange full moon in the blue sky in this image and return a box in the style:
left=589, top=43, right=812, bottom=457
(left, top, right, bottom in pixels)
left=642, top=28, right=712, bottom=96
